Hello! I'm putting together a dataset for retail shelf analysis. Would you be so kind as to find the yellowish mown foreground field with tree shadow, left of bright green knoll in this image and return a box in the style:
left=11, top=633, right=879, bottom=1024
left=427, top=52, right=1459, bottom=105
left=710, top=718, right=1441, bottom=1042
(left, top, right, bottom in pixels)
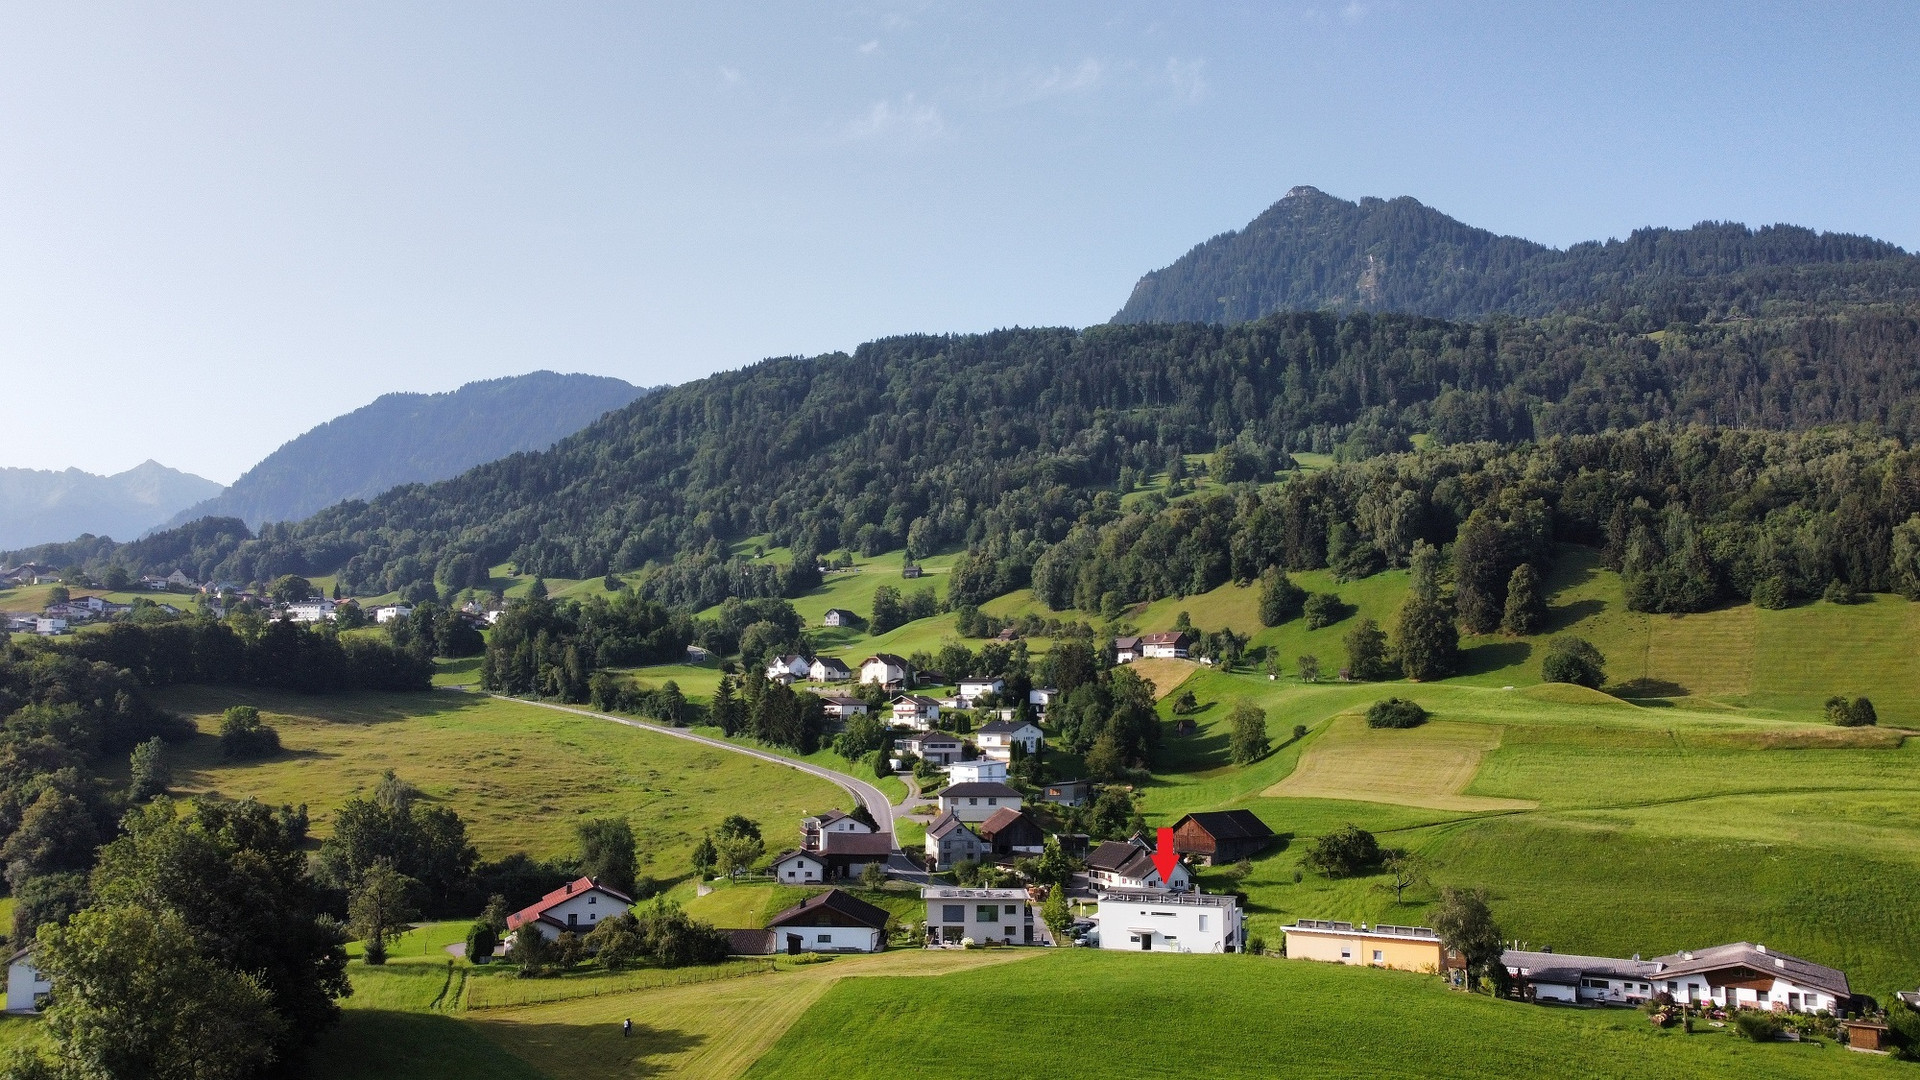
left=307, top=949, right=1039, bottom=1080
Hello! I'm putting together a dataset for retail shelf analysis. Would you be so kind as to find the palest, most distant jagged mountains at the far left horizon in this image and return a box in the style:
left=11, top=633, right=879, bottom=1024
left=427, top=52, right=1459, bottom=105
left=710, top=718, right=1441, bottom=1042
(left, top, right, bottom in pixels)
left=0, top=461, right=221, bottom=550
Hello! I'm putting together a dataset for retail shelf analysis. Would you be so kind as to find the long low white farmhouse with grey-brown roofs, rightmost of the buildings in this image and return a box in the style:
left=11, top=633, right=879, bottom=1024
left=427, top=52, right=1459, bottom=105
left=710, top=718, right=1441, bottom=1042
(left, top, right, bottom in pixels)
left=1501, top=942, right=1853, bottom=1015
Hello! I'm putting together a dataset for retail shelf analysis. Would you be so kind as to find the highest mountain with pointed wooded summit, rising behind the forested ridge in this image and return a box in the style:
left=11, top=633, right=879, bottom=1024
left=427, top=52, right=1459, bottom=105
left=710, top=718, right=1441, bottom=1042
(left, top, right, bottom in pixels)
left=1114, top=186, right=1920, bottom=322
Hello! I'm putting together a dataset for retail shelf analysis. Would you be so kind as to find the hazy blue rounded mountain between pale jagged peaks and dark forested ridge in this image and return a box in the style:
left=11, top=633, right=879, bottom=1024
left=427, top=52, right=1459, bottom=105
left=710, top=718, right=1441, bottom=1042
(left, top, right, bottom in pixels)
left=167, top=371, right=647, bottom=534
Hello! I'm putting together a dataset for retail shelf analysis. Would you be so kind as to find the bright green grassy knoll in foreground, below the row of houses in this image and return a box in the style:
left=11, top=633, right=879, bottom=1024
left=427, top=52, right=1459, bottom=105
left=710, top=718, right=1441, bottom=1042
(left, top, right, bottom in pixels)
left=747, top=949, right=1910, bottom=1080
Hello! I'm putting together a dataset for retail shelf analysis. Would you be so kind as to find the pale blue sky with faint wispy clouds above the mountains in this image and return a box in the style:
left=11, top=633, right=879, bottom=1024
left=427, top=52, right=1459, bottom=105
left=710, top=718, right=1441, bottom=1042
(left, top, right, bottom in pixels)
left=0, top=0, right=1920, bottom=482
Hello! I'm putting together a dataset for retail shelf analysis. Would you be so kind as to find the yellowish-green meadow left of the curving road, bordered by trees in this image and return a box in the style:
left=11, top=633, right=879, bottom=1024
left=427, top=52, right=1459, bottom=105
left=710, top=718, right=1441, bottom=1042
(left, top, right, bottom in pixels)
left=159, top=686, right=852, bottom=880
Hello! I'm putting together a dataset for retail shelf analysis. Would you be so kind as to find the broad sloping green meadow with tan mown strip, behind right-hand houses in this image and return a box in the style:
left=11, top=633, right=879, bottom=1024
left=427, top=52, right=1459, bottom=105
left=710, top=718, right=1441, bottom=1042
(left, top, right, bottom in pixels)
left=1142, top=671, right=1920, bottom=995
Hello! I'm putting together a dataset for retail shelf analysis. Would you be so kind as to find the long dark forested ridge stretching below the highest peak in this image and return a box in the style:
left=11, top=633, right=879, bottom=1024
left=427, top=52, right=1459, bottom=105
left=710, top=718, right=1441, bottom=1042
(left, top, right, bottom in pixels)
left=21, top=295, right=1920, bottom=601
